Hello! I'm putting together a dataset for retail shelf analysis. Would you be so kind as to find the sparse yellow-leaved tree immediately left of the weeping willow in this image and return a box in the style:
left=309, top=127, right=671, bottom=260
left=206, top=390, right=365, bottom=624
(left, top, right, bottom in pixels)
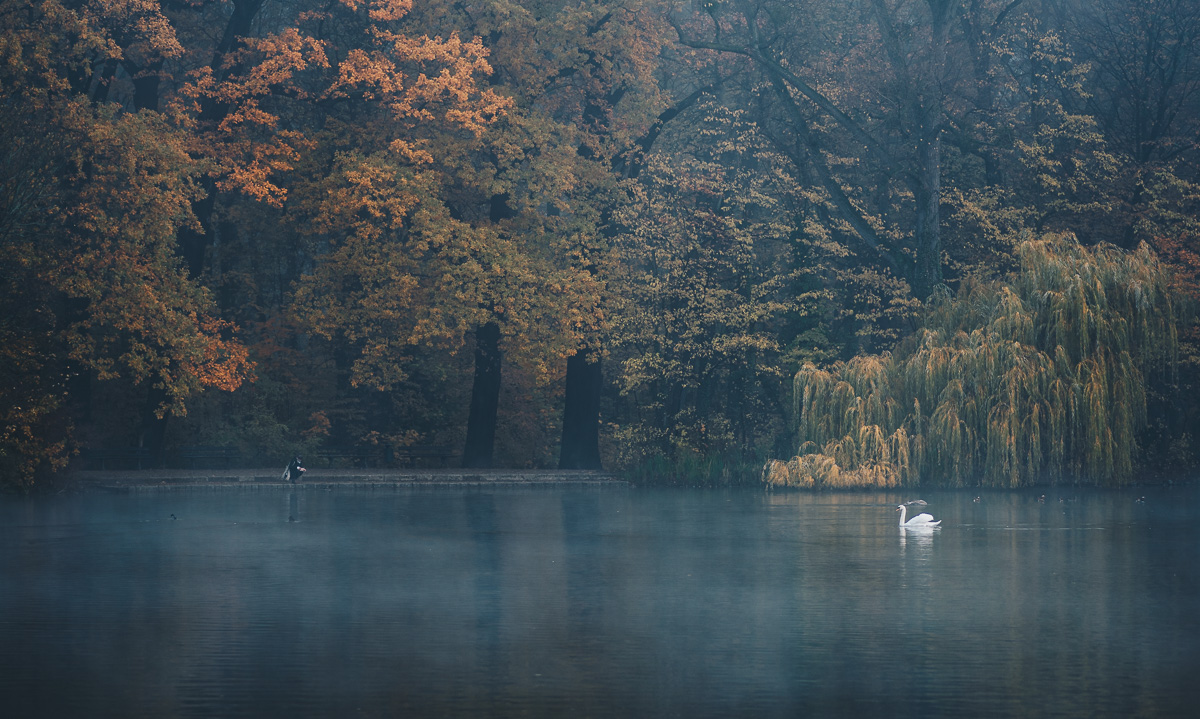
left=613, top=98, right=821, bottom=481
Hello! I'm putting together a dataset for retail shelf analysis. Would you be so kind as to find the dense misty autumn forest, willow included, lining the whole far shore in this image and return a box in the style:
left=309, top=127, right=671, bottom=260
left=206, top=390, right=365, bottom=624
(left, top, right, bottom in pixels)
left=0, top=0, right=1200, bottom=489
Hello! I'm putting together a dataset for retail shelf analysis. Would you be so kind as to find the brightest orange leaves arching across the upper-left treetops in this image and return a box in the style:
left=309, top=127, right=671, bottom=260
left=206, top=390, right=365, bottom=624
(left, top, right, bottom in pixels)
left=170, top=1, right=511, bottom=206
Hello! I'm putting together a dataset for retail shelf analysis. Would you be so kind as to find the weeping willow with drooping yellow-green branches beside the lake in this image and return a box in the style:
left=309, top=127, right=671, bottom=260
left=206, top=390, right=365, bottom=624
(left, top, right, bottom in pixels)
left=763, top=235, right=1178, bottom=487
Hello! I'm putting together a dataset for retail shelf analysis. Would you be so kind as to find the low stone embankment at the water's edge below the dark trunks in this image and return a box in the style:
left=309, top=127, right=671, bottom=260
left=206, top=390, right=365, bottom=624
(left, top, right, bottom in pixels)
left=71, top=468, right=628, bottom=492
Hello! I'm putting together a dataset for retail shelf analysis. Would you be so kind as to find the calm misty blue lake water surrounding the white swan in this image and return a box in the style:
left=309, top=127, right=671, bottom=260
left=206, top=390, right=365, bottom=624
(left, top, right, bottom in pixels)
left=0, top=486, right=1200, bottom=718
